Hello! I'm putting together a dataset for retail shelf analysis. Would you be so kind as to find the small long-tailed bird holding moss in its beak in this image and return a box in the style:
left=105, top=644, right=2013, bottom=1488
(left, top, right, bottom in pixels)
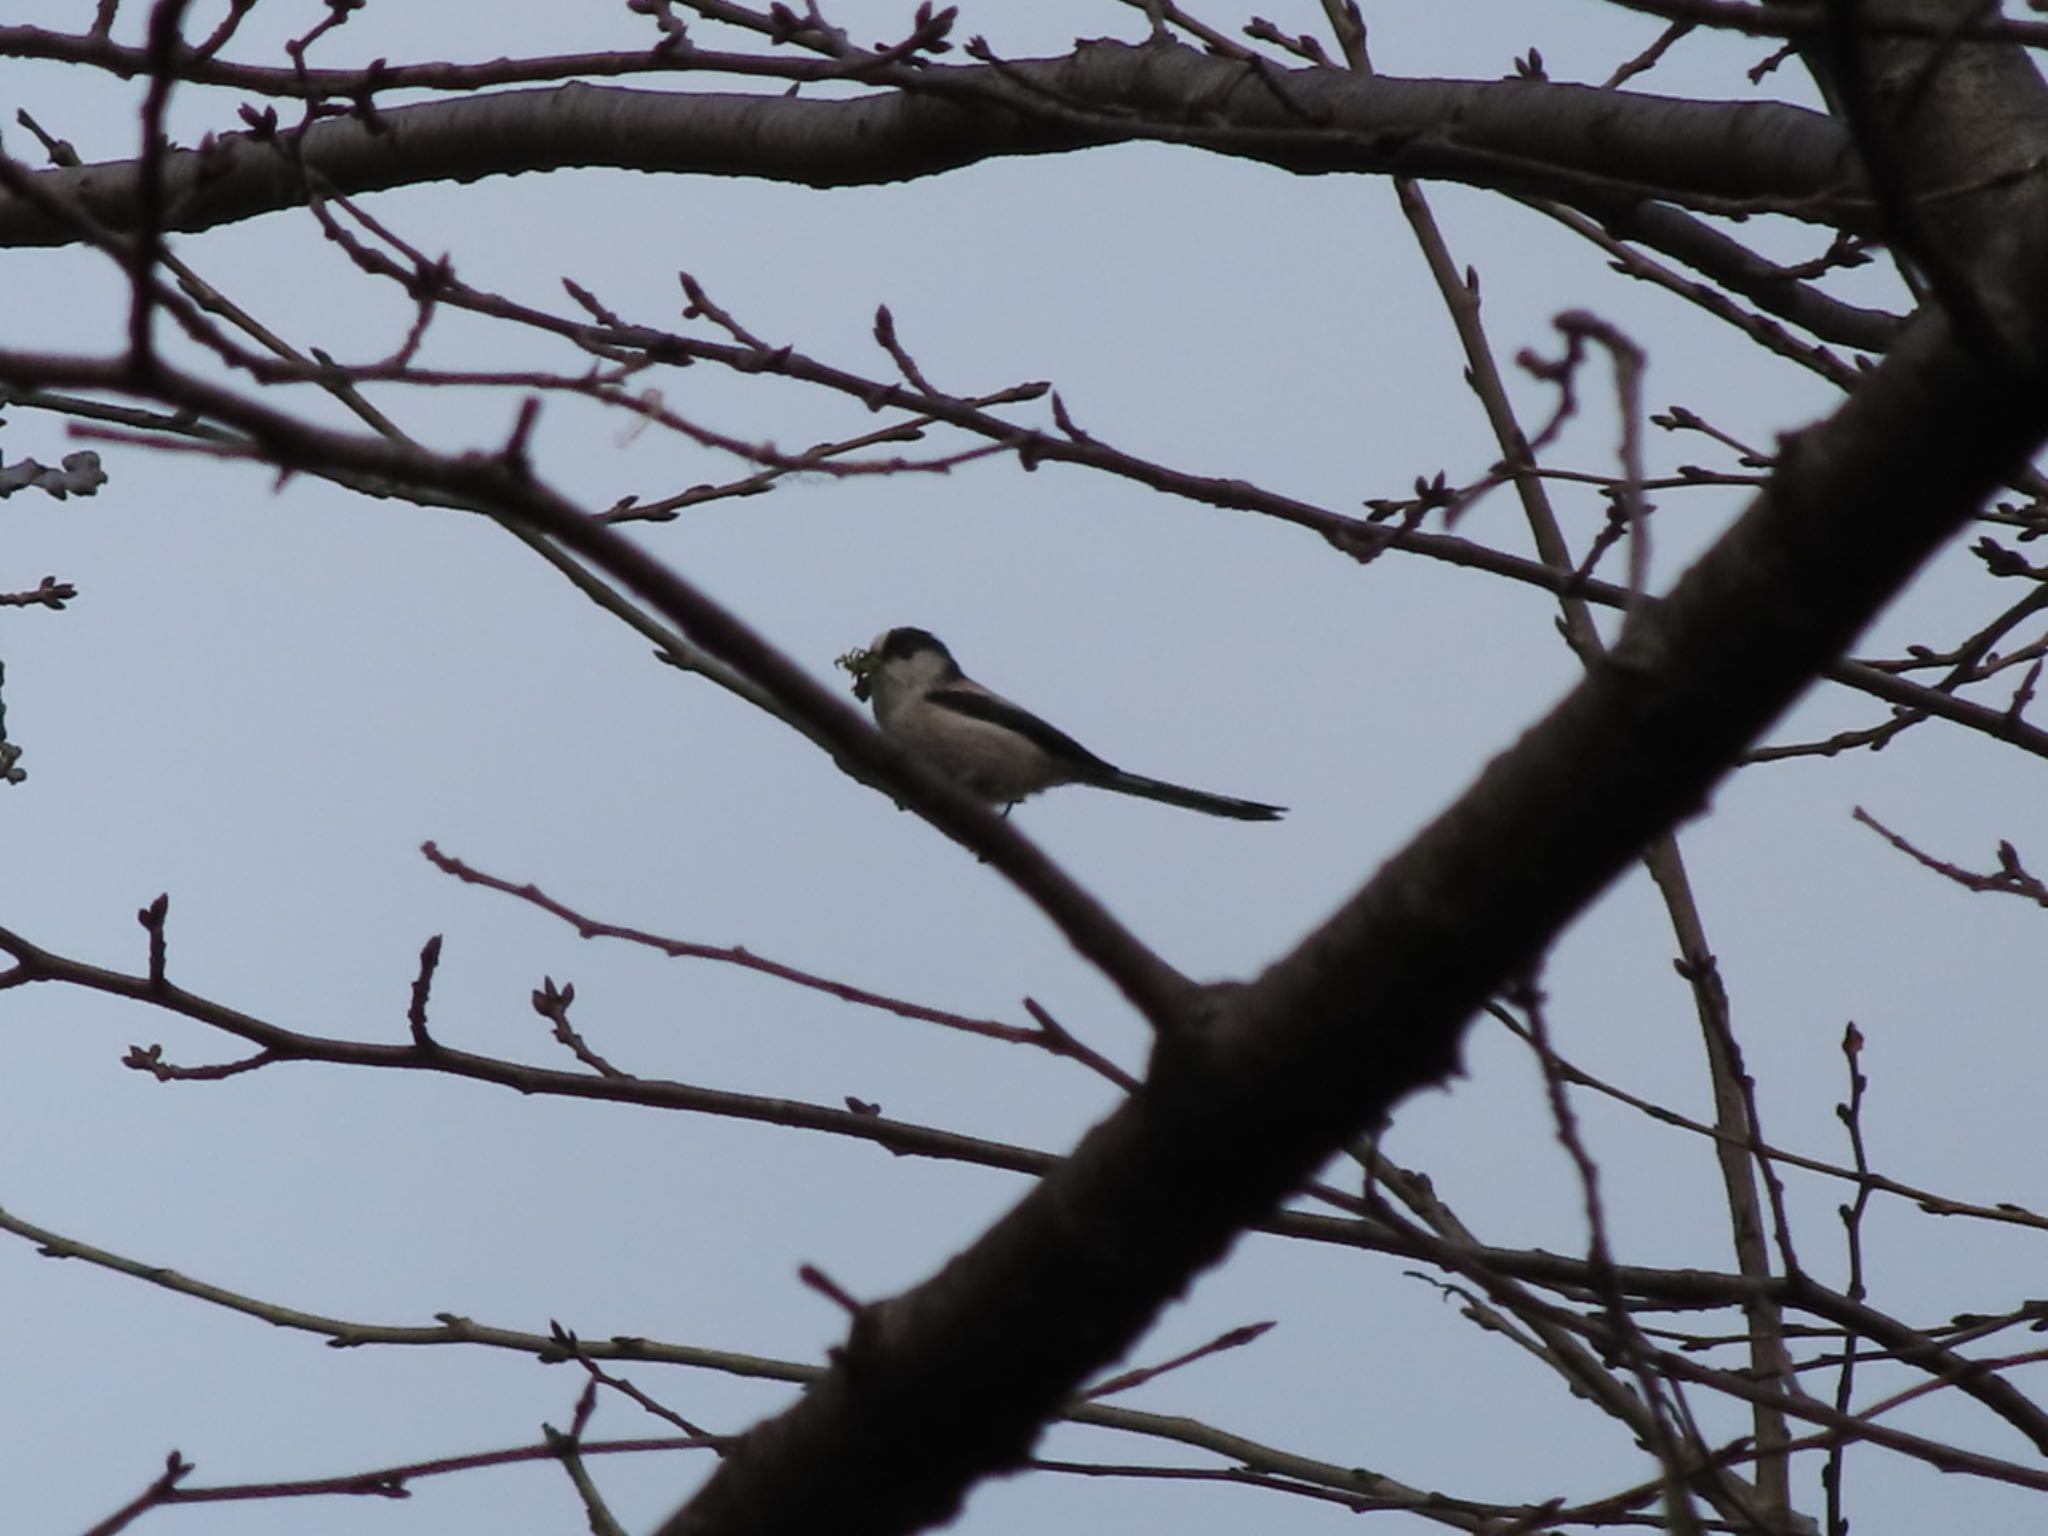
left=840, top=629, right=1284, bottom=821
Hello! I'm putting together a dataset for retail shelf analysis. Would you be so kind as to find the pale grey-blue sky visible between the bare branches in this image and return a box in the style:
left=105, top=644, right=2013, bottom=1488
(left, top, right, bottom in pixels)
left=0, top=0, right=2048, bottom=1536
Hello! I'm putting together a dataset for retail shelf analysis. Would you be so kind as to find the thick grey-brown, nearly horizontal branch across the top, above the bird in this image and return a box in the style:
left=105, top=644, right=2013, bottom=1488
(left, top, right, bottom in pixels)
left=0, top=33, right=1860, bottom=246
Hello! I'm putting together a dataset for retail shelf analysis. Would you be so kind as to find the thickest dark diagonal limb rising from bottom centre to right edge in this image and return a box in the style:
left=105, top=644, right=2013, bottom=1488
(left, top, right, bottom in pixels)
left=664, top=153, right=2048, bottom=1536
